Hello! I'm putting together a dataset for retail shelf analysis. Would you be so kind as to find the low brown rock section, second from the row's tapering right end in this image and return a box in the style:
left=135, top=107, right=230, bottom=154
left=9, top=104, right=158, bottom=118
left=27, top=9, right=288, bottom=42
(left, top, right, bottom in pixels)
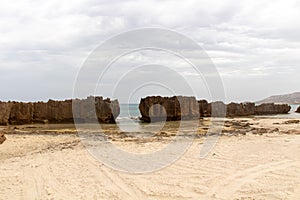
left=226, top=103, right=255, bottom=117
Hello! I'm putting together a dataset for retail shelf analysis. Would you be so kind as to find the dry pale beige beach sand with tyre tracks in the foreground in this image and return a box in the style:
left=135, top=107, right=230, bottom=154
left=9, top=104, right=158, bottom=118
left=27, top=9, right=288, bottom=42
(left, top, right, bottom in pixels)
left=0, top=118, right=300, bottom=199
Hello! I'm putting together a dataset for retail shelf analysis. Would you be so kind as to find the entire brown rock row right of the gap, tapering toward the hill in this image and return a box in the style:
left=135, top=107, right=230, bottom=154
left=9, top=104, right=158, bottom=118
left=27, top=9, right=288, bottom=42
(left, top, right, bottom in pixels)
left=139, top=96, right=291, bottom=122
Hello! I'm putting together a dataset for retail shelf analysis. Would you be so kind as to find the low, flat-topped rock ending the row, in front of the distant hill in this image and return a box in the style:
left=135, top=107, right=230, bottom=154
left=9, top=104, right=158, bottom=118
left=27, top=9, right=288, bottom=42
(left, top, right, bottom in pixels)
left=255, top=103, right=291, bottom=115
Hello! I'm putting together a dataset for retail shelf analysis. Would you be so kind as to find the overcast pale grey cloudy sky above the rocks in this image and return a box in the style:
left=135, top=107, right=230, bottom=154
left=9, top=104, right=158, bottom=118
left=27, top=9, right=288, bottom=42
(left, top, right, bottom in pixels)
left=0, top=0, right=300, bottom=102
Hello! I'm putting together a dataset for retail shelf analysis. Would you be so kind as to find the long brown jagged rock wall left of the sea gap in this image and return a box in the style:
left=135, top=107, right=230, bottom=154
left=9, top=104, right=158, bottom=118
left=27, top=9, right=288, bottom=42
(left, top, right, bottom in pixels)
left=0, top=97, right=120, bottom=125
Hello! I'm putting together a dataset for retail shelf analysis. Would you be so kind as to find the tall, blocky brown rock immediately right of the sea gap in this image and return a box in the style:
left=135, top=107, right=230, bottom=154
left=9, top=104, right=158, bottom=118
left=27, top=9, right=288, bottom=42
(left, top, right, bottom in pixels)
left=139, top=96, right=199, bottom=122
